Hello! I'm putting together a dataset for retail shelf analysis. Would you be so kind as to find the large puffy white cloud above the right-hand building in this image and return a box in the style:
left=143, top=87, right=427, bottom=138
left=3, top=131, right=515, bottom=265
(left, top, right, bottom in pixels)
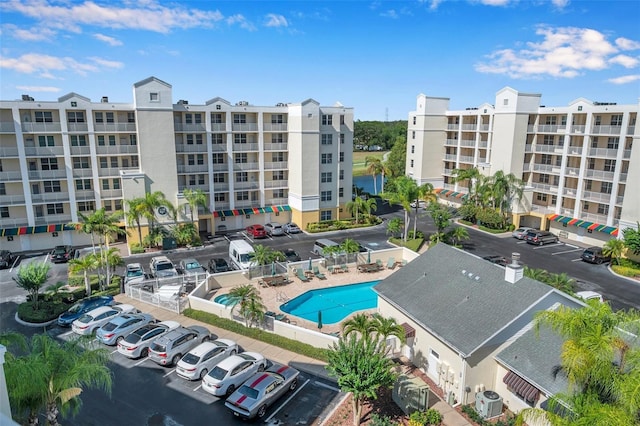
left=475, top=26, right=637, bottom=78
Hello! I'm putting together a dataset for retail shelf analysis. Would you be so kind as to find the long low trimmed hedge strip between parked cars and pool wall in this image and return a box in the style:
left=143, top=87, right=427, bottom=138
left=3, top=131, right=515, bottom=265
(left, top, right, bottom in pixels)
left=182, top=308, right=328, bottom=362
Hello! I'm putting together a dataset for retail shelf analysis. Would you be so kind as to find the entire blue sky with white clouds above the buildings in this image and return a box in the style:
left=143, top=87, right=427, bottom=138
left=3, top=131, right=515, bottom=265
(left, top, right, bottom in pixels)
left=0, top=0, right=640, bottom=120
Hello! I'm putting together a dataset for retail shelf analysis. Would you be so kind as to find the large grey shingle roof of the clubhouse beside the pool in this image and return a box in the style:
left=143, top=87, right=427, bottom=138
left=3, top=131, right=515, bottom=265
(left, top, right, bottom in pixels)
left=374, top=244, right=553, bottom=356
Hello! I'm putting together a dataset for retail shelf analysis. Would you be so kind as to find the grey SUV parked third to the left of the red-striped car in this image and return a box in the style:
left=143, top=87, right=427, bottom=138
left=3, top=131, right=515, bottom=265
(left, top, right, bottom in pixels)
left=149, top=325, right=211, bottom=366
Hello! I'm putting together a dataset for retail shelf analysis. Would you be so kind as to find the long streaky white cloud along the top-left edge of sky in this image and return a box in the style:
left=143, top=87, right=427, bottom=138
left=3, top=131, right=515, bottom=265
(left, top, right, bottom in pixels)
left=2, top=0, right=224, bottom=33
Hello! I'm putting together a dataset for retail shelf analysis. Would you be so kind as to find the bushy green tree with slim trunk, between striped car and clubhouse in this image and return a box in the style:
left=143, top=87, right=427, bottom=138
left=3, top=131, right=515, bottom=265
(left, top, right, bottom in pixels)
left=327, top=335, right=396, bottom=426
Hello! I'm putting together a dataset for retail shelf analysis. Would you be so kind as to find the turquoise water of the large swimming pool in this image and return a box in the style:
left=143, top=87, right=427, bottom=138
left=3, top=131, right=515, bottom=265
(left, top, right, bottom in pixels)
left=280, top=281, right=380, bottom=324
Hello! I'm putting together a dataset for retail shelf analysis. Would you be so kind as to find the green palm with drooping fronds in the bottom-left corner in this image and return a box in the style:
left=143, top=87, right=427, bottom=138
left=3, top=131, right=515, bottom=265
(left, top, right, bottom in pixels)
left=0, top=334, right=112, bottom=426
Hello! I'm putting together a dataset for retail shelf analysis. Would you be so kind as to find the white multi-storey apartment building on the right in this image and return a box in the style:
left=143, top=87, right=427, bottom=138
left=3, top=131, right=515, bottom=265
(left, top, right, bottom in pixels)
left=406, top=87, right=640, bottom=245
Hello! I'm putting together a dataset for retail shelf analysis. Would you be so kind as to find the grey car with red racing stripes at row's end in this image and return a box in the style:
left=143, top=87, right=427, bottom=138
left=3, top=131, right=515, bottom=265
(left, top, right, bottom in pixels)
left=224, top=363, right=300, bottom=419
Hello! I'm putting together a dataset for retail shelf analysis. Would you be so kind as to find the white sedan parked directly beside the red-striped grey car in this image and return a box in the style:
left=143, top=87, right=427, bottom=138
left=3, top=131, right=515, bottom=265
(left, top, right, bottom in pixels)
left=202, top=352, right=267, bottom=396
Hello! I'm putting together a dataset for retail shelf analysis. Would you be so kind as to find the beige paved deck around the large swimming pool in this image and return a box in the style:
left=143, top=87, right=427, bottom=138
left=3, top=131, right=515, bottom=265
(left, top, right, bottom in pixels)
left=250, top=265, right=400, bottom=333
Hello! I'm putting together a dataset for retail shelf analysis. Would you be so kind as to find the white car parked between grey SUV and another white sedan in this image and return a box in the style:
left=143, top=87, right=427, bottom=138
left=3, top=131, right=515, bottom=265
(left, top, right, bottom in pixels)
left=176, top=339, right=238, bottom=380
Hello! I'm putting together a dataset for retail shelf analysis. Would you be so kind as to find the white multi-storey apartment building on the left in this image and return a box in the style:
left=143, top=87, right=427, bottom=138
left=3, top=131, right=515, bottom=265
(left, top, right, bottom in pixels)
left=0, top=77, right=353, bottom=251
